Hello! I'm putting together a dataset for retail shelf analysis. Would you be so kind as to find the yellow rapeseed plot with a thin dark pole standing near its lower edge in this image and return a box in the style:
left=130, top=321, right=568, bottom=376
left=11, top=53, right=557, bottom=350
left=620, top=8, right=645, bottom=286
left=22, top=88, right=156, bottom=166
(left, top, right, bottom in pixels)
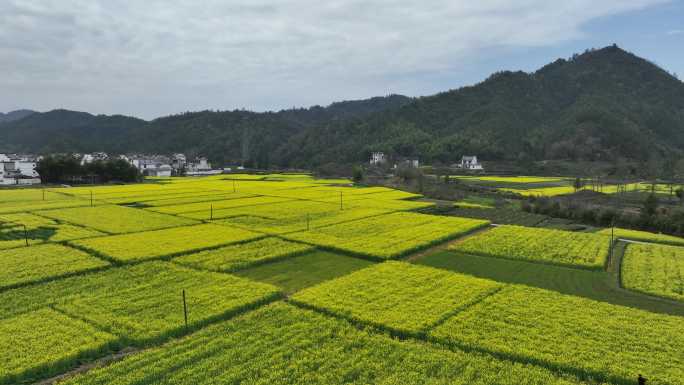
left=46, top=262, right=279, bottom=344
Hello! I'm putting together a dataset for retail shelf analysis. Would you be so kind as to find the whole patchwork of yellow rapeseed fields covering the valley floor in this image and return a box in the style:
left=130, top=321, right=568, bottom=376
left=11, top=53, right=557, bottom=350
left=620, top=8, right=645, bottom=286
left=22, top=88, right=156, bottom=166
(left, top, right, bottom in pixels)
left=0, top=173, right=684, bottom=385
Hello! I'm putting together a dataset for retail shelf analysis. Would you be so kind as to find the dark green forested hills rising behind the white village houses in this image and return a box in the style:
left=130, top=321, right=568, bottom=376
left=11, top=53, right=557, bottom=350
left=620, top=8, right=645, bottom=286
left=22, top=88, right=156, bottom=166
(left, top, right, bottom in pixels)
left=0, top=46, right=684, bottom=167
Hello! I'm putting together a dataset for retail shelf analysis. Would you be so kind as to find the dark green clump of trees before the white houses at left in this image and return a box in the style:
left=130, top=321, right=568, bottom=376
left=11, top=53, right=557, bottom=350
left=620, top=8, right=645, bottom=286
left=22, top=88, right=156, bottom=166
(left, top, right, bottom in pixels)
left=36, top=155, right=142, bottom=183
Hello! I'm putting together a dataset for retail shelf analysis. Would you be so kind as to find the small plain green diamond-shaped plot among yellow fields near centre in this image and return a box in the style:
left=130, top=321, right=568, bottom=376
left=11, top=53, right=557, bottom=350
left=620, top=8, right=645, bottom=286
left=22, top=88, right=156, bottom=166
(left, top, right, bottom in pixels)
left=234, top=251, right=373, bottom=294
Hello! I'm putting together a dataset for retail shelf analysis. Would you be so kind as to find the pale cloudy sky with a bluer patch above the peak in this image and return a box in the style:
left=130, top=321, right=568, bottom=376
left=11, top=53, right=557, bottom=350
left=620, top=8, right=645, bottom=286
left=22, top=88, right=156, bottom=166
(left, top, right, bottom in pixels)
left=0, top=0, right=684, bottom=119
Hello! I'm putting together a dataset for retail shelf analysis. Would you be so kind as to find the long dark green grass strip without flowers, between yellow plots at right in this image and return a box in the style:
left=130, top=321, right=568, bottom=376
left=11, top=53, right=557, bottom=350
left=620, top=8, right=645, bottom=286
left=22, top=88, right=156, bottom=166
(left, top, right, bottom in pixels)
left=416, top=251, right=684, bottom=316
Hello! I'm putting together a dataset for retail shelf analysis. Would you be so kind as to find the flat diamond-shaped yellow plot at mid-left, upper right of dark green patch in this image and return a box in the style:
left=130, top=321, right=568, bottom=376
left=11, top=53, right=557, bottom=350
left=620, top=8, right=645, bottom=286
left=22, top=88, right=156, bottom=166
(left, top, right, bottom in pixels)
left=38, top=205, right=197, bottom=234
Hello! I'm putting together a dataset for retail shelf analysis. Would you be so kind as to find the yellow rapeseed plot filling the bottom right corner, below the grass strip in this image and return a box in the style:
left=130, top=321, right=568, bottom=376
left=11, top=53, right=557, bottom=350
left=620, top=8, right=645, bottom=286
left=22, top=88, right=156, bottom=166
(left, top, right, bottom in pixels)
left=431, top=286, right=684, bottom=384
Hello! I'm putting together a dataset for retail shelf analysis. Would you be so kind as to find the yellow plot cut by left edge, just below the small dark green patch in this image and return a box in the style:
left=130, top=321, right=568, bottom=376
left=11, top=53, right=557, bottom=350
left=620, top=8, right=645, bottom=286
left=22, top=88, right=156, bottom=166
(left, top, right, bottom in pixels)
left=0, top=244, right=109, bottom=288
